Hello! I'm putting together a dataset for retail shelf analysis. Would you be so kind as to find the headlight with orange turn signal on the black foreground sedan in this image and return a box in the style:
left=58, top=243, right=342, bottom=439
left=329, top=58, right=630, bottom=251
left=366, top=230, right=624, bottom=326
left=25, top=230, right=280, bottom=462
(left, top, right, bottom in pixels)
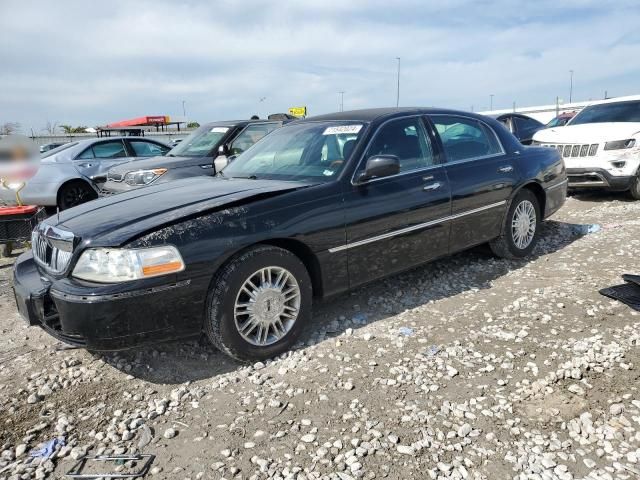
left=73, top=246, right=184, bottom=283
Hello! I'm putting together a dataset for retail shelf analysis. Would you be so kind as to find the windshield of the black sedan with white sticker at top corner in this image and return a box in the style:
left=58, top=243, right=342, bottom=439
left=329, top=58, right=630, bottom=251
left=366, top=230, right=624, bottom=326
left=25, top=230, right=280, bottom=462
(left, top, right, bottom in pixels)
left=222, top=122, right=364, bottom=181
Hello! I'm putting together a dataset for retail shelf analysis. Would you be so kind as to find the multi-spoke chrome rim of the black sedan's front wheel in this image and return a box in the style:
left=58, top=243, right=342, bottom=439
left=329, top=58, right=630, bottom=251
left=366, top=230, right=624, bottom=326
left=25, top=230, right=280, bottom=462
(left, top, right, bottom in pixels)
left=234, top=267, right=302, bottom=347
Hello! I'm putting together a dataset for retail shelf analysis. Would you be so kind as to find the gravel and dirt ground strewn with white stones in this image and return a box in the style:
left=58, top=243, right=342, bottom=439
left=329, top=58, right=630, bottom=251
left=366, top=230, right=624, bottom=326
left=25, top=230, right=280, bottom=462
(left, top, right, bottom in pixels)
left=0, top=194, right=640, bottom=480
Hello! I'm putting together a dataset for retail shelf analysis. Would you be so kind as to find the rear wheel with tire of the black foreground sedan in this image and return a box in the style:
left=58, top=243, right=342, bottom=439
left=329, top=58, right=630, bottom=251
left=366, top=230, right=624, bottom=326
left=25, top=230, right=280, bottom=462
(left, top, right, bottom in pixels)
left=489, top=188, right=541, bottom=259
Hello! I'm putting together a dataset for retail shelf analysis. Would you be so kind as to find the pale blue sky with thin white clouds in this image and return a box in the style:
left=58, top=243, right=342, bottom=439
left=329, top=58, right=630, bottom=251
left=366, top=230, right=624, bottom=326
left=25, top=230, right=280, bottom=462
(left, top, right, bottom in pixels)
left=0, top=0, right=640, bottom=133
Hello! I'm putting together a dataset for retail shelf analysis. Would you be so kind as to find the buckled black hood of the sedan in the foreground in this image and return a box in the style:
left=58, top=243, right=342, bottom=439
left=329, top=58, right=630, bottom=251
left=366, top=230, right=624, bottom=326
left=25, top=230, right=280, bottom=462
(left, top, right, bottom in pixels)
left=46, top=177, right=310, bottom=246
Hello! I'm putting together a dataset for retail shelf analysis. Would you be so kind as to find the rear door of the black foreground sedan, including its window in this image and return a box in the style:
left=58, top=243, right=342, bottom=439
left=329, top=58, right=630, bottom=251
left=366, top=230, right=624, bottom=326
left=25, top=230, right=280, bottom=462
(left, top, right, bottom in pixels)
left=429, top=115, right=519, bottom=252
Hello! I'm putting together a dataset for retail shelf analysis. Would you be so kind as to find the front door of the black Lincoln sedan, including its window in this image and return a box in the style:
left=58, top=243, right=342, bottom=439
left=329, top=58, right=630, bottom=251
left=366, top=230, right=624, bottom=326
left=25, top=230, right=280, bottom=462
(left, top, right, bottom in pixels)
left=342, top=116, right=451, bottom=287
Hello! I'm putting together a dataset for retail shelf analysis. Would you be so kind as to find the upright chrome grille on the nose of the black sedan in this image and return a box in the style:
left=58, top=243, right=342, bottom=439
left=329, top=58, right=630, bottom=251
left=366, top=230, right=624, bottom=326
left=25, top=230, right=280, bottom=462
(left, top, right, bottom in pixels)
left=31, top=224, right=73, bottom=274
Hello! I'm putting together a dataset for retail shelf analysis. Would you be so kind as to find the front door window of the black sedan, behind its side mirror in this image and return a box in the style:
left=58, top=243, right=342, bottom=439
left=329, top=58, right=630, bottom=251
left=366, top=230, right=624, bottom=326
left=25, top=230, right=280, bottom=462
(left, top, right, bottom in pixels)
left=365, top=117, right=434, bottom=172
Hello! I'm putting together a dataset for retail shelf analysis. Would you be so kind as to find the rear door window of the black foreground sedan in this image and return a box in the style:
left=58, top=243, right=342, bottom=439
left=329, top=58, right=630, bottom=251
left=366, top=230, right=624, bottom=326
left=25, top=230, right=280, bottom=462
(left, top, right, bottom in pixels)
left=430, top=115, right=502, bottom=162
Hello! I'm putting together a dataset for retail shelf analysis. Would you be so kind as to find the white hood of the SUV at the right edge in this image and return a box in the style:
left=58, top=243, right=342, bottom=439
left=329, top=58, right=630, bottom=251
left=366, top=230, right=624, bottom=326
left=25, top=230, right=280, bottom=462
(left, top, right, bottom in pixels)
left=533, top=122, right=640, bottom=144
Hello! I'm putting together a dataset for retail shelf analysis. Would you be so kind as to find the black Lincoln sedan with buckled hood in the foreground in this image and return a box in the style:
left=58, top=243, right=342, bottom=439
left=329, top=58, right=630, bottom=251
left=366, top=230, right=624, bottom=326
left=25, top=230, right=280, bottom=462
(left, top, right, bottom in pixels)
left=14, top=108, right=567, bottom=360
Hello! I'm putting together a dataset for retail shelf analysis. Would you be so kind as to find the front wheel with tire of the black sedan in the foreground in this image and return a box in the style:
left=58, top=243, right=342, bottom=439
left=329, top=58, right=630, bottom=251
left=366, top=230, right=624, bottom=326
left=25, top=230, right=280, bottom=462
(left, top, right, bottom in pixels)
left=204, top=245, right=312, bottom=361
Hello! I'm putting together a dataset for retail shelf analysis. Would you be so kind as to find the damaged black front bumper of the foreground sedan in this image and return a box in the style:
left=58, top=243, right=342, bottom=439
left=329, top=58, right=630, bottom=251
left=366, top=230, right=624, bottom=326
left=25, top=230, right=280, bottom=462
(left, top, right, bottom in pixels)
left=13, top=252, right=204, bottom=351
